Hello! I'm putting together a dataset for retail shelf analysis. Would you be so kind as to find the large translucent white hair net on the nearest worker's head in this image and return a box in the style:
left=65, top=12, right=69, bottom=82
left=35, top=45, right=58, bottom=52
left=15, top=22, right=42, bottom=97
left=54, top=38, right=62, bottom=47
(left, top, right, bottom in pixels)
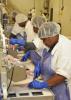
left=38, top=22, right=60, bottom=38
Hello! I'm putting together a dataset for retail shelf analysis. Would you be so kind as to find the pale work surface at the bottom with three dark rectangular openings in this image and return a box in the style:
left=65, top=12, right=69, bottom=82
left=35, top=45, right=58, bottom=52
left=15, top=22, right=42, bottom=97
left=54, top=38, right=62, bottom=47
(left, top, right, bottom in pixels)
left=7, top=86, right=54, bottom=100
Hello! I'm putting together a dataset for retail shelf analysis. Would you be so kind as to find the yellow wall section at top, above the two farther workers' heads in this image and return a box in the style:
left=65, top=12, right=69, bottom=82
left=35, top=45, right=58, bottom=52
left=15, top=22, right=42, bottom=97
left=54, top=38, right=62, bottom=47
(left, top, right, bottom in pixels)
left=8, top=0, right=44, bottom=14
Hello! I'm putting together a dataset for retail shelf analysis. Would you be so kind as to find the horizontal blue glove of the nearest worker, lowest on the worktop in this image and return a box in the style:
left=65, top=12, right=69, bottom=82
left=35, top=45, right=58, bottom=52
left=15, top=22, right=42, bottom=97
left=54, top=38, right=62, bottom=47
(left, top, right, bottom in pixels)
left=28, top=80, right=48, bottom=89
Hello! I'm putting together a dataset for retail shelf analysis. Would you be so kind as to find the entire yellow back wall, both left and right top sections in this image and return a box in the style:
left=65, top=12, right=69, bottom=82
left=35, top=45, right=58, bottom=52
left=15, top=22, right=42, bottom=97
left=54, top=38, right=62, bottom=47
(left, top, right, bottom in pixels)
left=8, top=0, right=71, bottom=37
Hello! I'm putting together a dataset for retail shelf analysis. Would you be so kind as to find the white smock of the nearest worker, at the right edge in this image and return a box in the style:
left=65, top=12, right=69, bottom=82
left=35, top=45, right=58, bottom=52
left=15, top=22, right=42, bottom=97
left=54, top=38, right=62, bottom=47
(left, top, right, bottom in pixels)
left=51, top=35, right=71, bottom=99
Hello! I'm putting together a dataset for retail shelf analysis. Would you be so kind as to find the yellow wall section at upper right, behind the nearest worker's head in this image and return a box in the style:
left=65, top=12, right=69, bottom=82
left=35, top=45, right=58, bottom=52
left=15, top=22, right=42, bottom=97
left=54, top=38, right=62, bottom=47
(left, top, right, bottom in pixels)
left=51, top=0, right=71, bottom=37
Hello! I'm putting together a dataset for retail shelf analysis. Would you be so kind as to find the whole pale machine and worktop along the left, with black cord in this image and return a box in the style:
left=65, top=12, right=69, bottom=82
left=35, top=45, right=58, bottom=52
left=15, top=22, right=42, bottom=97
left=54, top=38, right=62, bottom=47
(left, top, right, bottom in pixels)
left=0, top=23, right=54, bottom=100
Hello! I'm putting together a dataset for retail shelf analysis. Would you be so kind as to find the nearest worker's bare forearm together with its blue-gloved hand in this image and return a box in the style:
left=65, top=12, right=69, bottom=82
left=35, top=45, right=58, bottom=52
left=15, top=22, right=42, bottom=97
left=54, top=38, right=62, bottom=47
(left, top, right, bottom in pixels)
left=28, top=74, right=66, bottom=89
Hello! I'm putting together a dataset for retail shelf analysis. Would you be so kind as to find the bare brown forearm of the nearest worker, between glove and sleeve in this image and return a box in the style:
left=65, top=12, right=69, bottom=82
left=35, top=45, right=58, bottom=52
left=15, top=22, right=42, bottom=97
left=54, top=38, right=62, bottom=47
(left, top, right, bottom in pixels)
left=47, top=74, right=66, bottom=87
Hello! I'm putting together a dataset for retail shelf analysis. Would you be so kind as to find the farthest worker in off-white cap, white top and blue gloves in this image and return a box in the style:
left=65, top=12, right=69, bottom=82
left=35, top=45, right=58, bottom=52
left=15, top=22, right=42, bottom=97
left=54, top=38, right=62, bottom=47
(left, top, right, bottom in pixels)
left=10, top=13, right=28, bottom=50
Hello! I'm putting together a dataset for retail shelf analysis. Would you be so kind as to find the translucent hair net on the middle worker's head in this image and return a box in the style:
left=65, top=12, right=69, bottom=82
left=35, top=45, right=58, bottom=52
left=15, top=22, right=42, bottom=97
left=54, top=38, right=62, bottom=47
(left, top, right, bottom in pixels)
left=32, top=16, right=46, bottom=28
